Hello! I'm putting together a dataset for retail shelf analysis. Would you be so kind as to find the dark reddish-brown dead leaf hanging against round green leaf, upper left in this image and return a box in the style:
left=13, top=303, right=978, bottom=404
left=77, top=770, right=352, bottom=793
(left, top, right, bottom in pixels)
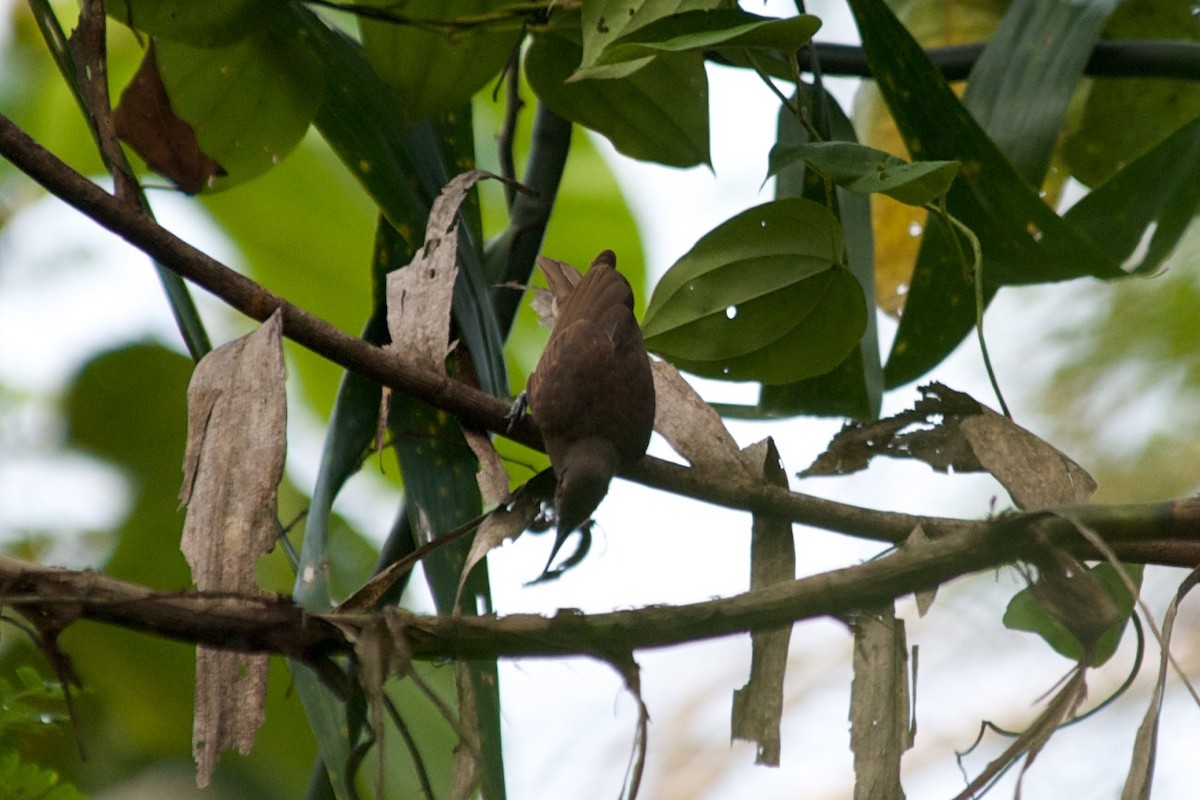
left=114, top=43, right=226, bottom=194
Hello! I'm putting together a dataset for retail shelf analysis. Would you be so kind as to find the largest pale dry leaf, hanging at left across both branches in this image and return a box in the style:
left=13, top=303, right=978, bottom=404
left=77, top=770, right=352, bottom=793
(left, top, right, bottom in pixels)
left=180, top=312, right=287, bottom=787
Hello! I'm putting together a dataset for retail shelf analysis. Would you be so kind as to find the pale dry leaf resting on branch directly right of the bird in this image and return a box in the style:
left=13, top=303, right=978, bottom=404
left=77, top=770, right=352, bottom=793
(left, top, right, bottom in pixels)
left=650, top=359, right=761, bottom=479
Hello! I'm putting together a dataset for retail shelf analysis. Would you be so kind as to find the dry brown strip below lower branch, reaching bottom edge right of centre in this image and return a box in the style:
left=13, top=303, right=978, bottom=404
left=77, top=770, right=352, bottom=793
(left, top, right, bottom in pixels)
left=850, top=606, right=910, bottom=800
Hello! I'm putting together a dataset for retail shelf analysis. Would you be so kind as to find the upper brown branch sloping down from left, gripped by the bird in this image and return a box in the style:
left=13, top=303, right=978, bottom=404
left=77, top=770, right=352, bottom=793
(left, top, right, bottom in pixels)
left=0, top=114, right=1200, bottom=556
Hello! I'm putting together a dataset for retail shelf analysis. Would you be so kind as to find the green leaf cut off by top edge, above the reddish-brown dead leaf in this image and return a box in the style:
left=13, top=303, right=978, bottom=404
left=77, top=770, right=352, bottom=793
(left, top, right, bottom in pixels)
left=104, top=0, right=274, bottom=47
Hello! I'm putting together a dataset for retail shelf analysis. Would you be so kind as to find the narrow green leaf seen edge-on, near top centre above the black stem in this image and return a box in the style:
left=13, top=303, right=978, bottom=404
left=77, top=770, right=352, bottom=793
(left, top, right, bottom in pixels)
left=575, top=8, right=821, bottom=72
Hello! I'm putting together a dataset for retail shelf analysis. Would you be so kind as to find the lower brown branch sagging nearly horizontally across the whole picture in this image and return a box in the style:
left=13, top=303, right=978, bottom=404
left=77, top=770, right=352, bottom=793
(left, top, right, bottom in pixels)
left=0, top=500, right=1200, bottom=663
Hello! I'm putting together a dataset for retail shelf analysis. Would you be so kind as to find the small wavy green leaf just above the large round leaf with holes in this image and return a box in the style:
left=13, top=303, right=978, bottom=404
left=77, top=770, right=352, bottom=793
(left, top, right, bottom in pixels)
left=767, top=142, right=959, bottom=205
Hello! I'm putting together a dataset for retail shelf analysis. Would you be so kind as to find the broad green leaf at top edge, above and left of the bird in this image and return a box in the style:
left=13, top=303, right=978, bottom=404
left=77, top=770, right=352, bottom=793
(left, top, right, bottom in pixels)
left=359, top=0, right=522, bottom=122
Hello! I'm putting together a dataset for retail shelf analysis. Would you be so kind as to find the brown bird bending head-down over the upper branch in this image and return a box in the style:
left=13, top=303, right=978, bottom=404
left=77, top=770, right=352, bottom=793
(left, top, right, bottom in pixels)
left=527, top=249, right=654, bottom=568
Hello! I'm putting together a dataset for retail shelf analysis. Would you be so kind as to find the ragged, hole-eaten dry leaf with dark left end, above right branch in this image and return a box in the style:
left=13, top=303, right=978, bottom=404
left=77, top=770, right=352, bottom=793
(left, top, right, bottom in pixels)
left=800, top=384, right=1096, bottom=509
